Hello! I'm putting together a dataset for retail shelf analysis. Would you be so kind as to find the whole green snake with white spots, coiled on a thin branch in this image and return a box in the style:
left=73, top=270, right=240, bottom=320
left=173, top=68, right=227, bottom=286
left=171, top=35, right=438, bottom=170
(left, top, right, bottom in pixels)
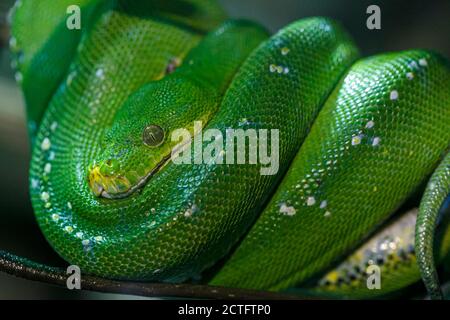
left=11, top=0, right=450, bottom=298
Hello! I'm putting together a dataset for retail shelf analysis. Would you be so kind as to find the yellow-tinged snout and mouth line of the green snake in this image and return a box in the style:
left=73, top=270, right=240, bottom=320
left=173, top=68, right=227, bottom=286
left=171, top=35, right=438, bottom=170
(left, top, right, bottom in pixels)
left=88, top=155, right=171, bottom=199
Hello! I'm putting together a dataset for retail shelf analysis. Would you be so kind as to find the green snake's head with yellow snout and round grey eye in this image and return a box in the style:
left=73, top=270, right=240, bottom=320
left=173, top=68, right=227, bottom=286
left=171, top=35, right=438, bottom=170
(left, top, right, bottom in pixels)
left=88, top=77, right=215, bottom=199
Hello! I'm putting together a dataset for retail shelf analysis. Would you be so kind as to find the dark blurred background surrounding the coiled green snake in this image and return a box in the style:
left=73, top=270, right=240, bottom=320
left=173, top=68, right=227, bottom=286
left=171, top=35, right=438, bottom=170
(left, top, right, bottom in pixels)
left=0, top=0, right=450, bottom=299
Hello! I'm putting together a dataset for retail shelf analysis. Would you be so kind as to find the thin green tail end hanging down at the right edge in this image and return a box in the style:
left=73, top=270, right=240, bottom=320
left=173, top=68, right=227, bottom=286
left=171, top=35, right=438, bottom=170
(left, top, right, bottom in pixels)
left=415, top=153, right=450, bottom=299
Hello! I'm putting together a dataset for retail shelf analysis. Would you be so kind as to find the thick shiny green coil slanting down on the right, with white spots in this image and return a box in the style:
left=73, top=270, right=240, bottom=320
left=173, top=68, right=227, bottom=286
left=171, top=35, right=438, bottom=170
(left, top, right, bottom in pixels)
left=212, top=50, right=450, bottom=290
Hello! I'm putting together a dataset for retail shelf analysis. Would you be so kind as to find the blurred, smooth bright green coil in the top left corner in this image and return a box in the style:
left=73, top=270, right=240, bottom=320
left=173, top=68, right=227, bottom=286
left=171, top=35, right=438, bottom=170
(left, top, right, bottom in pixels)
left=10, top=0, right=105, bottom=139
